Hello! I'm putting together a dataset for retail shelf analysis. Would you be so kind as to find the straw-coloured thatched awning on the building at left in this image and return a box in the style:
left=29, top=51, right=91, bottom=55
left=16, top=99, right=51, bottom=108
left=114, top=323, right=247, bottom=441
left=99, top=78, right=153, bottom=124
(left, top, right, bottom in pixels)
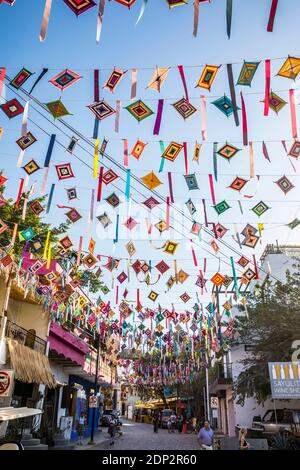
left=6, top=338, right=56, bottom=388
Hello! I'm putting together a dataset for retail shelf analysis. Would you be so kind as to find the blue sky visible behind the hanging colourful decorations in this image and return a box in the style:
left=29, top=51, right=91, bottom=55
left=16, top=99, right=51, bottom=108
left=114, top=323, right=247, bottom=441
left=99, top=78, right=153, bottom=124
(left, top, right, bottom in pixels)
left=0, top=0, right=300, bottom=310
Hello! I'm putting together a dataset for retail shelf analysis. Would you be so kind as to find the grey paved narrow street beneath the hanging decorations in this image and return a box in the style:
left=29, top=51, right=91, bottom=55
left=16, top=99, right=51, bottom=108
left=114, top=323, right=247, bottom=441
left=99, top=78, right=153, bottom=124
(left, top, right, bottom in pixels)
left=91, top=421, right=199, bottom=450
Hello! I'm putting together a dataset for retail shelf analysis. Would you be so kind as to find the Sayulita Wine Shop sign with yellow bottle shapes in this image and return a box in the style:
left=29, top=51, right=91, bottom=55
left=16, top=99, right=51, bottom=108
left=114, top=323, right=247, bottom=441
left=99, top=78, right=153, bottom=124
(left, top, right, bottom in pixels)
left=268, top=362, right=300, bottom=399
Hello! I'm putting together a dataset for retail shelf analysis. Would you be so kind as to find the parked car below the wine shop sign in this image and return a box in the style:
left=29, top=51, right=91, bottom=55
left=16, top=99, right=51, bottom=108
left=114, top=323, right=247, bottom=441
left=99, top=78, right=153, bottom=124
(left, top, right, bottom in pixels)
left=252, top=408, right=300, bottom=435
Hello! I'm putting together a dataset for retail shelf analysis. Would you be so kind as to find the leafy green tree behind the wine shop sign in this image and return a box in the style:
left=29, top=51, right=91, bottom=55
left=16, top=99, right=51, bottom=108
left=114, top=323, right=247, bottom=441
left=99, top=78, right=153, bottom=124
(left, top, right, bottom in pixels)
left=235, top=264, right=300, bottom=404
